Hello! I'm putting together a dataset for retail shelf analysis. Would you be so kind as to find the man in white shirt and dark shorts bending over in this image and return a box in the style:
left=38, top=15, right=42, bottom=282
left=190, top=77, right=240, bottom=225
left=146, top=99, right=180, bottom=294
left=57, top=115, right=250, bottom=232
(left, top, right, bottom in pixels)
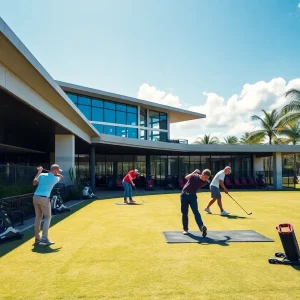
left=204, top=166, right=231, bottom=216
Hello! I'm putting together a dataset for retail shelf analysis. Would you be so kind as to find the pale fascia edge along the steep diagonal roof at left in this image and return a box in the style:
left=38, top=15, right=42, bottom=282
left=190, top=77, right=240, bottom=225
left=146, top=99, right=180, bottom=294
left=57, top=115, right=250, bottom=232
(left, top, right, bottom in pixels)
left=0, top=17, right=99, bottom=136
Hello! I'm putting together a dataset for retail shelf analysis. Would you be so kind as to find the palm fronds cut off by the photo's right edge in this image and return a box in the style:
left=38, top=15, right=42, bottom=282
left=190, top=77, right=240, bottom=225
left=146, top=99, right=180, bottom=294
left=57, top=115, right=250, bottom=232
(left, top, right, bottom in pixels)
left=281, top=89, right=300, bottom=123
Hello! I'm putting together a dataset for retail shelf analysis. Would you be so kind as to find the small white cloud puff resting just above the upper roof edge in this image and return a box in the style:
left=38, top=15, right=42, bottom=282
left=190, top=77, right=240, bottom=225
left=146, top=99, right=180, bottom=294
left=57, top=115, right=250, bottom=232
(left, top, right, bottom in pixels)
left=137, top=83, right=182, bottom=108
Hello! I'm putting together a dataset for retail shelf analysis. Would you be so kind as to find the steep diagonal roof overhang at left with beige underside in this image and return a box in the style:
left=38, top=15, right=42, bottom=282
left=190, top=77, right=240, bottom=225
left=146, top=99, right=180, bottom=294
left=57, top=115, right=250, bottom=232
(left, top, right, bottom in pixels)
left=0, top=17, right=99, bottom=142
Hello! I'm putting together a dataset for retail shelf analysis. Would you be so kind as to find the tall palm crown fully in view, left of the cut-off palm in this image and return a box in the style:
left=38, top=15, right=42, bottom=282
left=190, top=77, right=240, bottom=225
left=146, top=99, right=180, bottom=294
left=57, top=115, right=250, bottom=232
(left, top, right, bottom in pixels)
left=249, top=109, right=282, bottom=145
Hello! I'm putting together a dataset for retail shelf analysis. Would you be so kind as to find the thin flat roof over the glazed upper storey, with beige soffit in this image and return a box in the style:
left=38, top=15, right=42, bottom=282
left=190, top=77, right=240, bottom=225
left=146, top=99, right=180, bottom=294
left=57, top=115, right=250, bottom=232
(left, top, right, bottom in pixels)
left=57, top=81, right=206, bottom=123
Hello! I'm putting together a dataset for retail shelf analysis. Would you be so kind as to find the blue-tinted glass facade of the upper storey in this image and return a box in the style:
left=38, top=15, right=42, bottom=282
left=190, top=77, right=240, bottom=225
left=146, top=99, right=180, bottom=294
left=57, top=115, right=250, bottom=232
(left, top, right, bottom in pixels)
left=66, top=92, right=168, bottom=142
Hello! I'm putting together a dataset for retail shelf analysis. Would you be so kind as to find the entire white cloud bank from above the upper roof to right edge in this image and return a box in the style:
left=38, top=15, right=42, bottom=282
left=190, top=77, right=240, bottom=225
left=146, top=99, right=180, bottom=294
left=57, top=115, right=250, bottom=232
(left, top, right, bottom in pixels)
left=138, top=78, right=300, bottom=142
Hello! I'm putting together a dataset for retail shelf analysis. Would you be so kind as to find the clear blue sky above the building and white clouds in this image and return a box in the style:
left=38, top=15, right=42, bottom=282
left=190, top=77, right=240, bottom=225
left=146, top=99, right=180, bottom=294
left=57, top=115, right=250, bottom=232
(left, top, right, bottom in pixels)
left=0, top=0, right=300, bottom=141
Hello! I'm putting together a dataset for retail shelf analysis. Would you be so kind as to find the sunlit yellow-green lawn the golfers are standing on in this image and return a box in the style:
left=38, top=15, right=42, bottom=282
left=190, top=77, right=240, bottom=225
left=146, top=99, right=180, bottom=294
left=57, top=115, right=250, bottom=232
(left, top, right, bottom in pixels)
left=0, top=191, right=300, bottom=300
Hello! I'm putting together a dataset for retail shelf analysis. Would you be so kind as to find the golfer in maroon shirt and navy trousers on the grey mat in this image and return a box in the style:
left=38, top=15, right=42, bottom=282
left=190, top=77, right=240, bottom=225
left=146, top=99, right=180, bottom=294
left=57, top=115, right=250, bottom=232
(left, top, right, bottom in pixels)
left=180, top=169, right=211, bottom=237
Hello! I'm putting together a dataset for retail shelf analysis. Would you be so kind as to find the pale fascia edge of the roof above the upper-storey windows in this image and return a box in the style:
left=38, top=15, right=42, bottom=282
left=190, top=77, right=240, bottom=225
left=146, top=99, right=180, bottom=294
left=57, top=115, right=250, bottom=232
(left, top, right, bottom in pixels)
left=56, top=80, right=206, bottom=118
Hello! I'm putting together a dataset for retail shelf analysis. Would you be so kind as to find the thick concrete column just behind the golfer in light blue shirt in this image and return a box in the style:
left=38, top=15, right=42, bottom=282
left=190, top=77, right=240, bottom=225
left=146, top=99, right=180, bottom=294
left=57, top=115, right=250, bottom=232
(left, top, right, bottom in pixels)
left=55, top=134, right=75, bottom=186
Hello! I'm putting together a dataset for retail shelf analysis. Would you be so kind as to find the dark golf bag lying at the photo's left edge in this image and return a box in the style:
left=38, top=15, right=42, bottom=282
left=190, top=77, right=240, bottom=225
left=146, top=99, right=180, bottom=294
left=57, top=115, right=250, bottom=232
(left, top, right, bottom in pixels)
left=0, top=208, right=23, bottom=243
